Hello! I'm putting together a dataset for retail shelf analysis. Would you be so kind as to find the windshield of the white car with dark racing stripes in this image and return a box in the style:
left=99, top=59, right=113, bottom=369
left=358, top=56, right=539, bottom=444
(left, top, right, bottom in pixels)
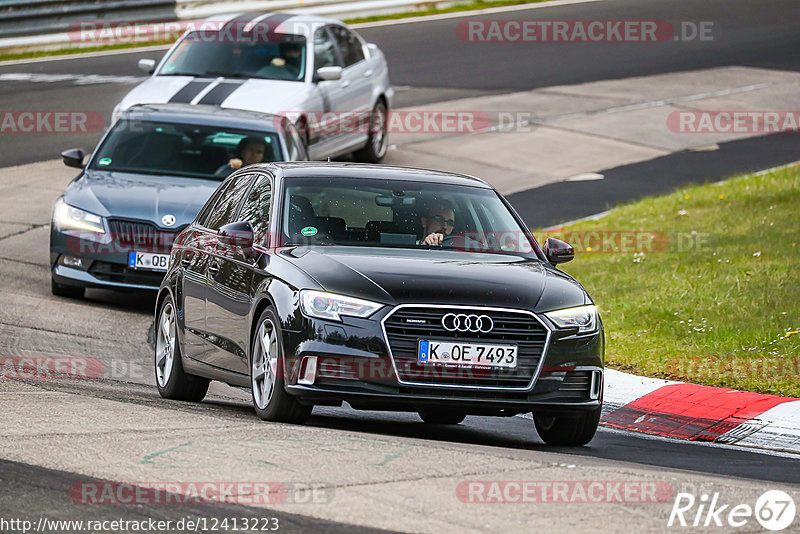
left=158, top=32, right=306, bottom=81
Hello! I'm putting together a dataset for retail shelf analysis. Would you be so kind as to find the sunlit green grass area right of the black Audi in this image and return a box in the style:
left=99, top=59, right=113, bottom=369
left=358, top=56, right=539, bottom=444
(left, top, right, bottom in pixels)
left=536, top=166, right=800, bottom=397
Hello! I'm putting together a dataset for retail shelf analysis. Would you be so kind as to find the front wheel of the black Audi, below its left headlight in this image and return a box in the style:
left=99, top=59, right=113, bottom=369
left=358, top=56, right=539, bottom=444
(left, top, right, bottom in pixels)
left=250, top=308, right=313, bottom=424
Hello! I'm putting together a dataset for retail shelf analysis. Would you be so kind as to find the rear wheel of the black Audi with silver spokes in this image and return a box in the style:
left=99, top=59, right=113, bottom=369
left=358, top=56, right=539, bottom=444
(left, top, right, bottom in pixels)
left=153, top=296, right=209, bottom=402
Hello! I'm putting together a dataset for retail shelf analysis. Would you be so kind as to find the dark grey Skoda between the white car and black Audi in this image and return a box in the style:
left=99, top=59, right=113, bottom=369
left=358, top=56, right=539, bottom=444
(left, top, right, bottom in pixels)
left=50, top=104, right=308, bottom=298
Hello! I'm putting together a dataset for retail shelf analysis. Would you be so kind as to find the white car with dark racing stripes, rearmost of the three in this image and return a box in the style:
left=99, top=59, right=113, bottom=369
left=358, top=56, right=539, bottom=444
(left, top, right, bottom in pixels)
left=113, top=13, right=394, bottom=163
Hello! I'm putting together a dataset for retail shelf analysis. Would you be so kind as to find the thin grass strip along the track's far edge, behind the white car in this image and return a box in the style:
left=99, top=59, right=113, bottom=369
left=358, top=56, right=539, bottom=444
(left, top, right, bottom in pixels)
left=0, top=0, right=548, bottom=61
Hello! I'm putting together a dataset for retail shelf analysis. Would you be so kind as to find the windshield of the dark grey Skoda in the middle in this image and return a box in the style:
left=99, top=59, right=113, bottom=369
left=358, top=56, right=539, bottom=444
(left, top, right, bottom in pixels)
left=89, top=119, right=284, bottom=180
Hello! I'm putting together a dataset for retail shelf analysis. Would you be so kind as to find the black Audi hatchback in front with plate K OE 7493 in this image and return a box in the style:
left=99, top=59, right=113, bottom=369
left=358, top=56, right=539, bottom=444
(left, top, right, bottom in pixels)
left=155, top=163, right=605, bottom=445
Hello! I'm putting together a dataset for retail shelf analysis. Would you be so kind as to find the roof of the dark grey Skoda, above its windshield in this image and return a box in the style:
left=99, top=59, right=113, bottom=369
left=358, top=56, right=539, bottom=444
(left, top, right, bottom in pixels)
left=122, top=104, right=282, bottom=132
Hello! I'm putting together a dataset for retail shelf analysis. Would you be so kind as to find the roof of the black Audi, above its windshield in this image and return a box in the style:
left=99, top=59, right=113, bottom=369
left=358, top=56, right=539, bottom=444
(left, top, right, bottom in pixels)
left=254, top=161, right=492, bottom=189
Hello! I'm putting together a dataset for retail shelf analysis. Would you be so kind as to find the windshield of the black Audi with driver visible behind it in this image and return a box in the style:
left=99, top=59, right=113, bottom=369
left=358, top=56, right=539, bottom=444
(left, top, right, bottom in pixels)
left=281, top=178, right=535, bottom=257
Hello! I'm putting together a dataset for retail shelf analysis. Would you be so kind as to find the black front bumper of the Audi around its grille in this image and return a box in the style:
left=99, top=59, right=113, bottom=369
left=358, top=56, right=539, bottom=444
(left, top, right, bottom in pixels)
left=284, top=310, right=604, bottom=415
